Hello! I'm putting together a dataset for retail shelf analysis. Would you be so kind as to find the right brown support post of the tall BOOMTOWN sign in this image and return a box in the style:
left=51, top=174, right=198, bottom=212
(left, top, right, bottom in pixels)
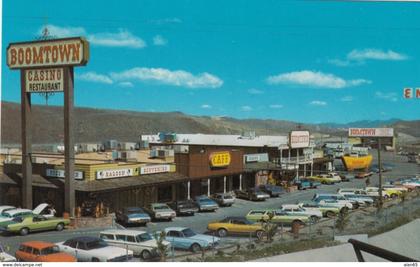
left=63, top=67, right=75, bottom=217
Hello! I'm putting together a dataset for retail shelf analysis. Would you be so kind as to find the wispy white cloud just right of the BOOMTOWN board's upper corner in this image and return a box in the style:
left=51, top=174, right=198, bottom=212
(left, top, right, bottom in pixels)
left=88, top=29, right=146, bottom=48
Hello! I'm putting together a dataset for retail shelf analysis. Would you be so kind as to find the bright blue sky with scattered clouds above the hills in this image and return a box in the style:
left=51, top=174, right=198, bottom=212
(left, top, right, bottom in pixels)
left=2, top=0, right=420, bottom=123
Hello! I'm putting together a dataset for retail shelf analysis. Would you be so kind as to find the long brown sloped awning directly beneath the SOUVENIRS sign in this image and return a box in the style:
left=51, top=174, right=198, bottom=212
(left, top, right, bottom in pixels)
left=73, top=172, right=189, bottom=192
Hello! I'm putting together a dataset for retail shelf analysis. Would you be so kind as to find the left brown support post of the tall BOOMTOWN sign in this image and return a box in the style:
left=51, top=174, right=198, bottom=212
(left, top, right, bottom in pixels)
left=20, top=70, right=32, bottom=209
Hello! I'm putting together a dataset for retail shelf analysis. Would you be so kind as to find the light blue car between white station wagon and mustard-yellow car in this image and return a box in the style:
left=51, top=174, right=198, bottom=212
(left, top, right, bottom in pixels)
left=164, top=227, right=220, bottom=252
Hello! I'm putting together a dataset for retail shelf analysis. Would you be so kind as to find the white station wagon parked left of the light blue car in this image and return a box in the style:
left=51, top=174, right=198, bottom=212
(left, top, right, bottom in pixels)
left=99, top=229, right=171, bottom=260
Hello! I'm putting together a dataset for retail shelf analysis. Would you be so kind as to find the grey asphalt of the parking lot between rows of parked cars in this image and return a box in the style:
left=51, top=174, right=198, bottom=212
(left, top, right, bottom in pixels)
left=0, top=151, right=419, bottom=260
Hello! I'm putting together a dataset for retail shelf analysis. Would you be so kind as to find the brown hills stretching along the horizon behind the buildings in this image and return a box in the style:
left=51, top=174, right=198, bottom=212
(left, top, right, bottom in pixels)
left=1, top=102, right=420, bottom=144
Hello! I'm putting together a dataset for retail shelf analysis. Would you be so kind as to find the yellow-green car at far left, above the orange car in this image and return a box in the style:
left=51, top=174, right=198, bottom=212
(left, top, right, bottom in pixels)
left=5, top=215, right=70, bottom=235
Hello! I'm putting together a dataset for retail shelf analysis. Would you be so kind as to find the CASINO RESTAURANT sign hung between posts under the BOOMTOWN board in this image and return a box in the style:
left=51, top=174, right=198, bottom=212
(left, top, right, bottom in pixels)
left=25, top=68, right=64, bottom=93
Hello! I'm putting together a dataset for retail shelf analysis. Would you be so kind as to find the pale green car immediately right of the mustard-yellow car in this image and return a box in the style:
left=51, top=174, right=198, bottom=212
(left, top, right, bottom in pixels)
left=246, top=210, right=310, bottom=224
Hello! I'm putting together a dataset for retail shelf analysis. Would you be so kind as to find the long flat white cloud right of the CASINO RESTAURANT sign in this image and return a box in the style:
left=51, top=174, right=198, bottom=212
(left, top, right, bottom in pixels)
left=111, top=68, right=223, bottom=88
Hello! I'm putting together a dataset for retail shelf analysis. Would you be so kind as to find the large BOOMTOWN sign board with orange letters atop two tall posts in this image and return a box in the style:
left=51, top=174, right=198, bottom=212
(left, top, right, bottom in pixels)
left=7, top=37, right=89, bottom=69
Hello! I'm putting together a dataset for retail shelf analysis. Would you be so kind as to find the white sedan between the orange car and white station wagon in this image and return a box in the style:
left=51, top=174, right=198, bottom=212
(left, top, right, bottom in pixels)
left=56, top=236, right=133, bottom=262
